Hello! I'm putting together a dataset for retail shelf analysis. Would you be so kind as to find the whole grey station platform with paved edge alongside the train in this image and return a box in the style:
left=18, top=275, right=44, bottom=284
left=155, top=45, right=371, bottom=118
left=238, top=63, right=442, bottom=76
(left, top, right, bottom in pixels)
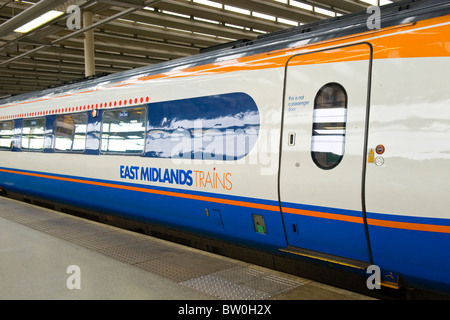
left=0, top=197, right=373, bottom=301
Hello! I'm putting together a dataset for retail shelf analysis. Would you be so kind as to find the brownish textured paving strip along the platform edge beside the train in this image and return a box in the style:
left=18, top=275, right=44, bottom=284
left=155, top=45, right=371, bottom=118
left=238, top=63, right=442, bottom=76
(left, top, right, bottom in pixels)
left=0, top=198, right=303, bottom=300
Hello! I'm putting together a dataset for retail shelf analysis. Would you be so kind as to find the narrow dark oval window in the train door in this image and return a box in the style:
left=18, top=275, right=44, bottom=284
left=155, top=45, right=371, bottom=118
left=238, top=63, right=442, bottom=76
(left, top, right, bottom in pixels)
left=311, top=83, right=347, bottom=170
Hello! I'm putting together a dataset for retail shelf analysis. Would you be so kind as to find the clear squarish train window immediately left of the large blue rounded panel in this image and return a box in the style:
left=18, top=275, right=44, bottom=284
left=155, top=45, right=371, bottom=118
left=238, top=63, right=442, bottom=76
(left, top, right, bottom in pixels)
left=101, top=107, right=146, bottom=154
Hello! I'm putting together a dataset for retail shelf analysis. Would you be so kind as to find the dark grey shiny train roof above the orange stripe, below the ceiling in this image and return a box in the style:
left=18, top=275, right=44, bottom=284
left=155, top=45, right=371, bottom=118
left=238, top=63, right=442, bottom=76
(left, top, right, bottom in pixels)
left=0, top=0, right=450, bottom=104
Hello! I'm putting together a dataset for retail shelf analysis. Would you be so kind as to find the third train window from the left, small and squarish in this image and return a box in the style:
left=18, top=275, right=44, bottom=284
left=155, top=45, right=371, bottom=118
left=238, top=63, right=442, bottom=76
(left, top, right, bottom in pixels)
left=55, top=113, right=87, bottom=152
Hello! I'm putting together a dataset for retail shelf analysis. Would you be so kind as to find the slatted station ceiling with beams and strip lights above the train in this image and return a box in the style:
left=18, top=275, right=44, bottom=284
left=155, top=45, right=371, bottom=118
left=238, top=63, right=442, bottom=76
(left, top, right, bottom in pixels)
left=0, top=0, right=392, bottom=98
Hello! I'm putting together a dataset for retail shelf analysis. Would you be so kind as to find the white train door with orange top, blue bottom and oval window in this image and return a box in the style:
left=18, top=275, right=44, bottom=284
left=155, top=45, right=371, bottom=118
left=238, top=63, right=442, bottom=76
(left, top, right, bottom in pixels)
left=279, top=43, right=371, bottom=261
